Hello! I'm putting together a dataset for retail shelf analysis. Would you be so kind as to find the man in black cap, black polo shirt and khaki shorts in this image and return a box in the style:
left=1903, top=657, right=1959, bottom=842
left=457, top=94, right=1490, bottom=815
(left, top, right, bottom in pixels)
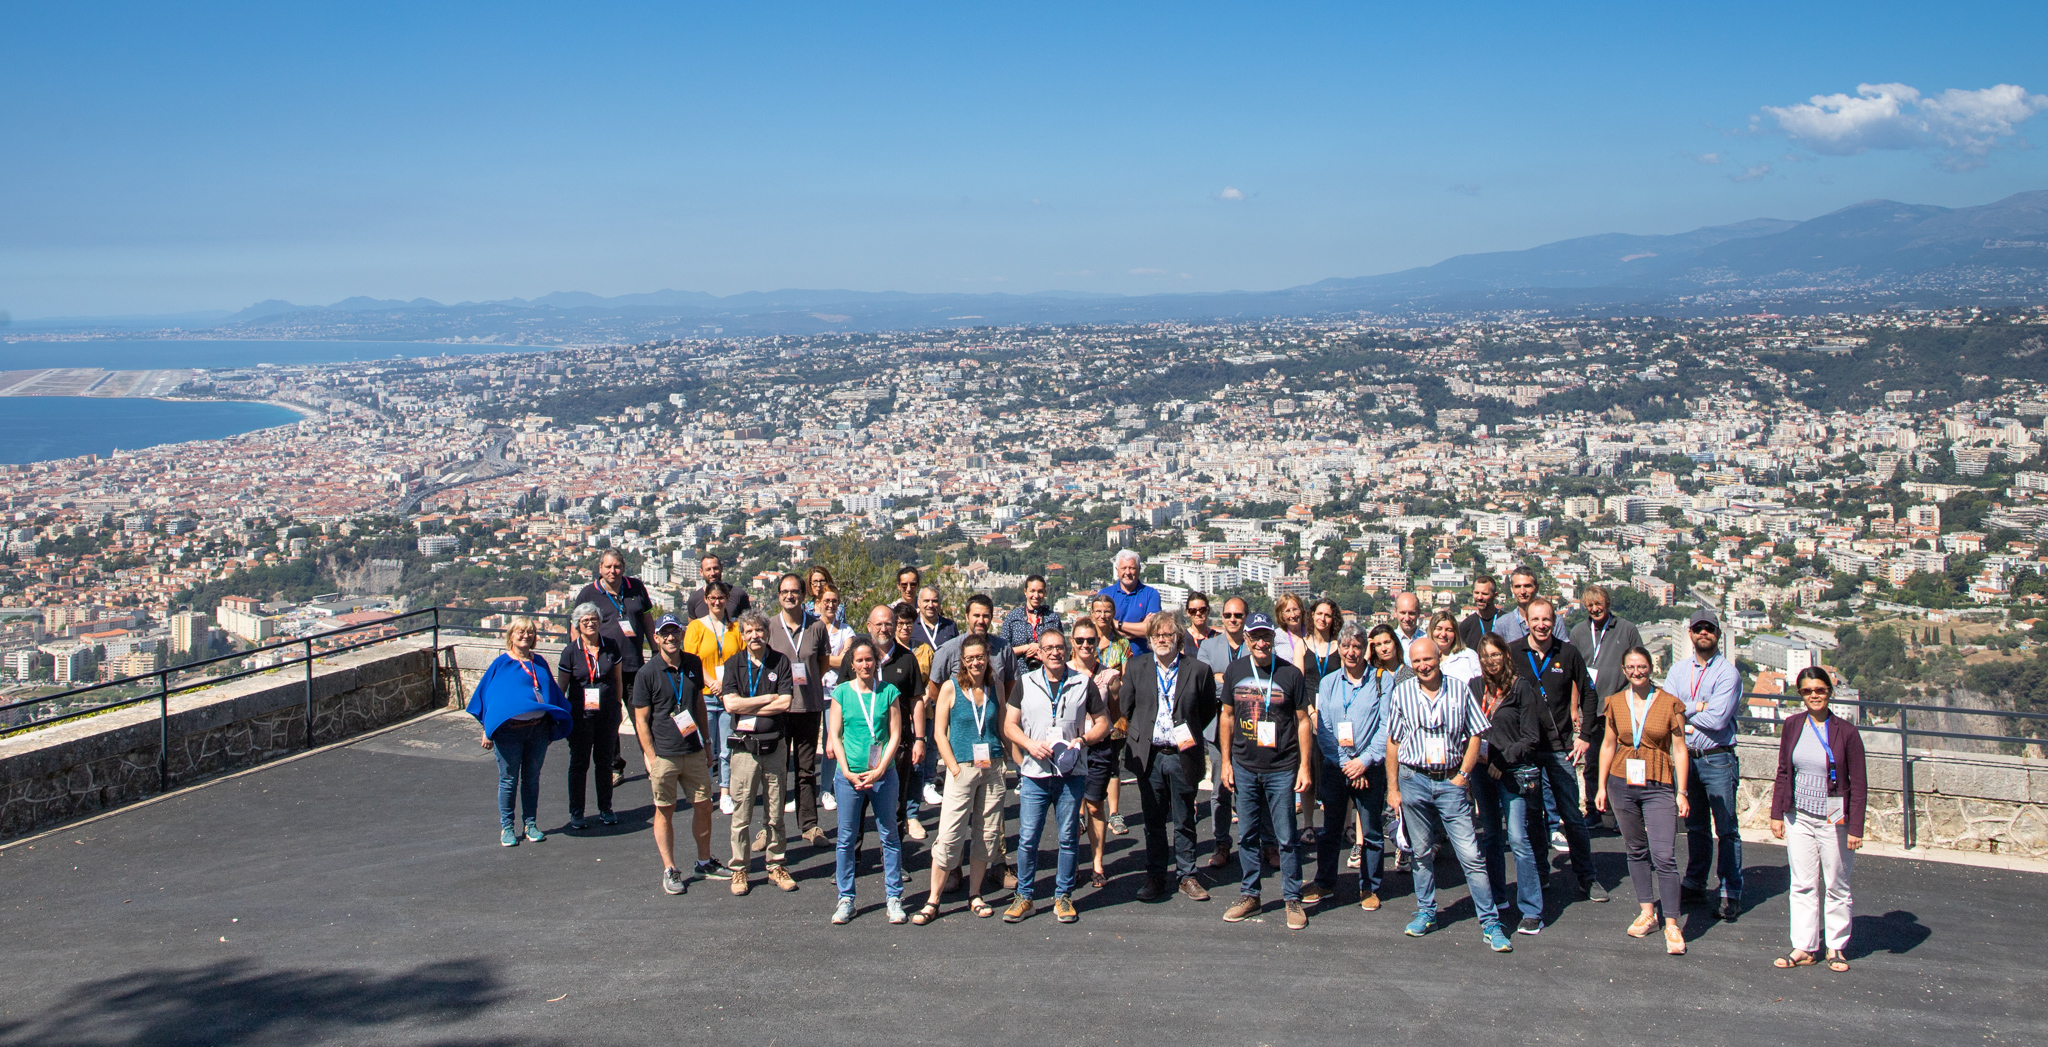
left=631, top=615, right=731, bottom=893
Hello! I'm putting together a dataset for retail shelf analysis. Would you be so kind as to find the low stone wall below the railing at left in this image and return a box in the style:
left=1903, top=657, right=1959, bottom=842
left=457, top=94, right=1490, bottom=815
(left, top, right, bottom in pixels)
left=0, top=641, right=453, bottom=840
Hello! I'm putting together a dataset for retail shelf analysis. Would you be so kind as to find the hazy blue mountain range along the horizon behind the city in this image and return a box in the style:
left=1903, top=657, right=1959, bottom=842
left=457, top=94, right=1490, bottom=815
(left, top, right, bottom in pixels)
left=23, top=191, right=2048, bottom=342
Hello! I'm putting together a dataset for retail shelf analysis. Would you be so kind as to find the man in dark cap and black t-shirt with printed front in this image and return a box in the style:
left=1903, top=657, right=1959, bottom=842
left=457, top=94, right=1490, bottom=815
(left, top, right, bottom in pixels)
left=1219, top=613, right=1315, bottom=930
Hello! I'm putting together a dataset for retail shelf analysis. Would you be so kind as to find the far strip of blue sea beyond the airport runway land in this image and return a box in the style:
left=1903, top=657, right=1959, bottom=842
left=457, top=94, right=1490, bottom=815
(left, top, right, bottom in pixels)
left=0, top=338, right=559, bottom=371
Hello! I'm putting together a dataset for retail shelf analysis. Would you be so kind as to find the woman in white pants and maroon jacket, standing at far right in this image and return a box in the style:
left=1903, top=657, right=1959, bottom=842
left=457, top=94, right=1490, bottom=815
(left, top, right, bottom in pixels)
left=1772, top=666, right=1866, bottom=973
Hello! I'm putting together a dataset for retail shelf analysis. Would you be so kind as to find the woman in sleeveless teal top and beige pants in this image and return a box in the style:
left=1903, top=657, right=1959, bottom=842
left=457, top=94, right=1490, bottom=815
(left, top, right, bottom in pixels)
left=909, top=635, right=1004, bottom=926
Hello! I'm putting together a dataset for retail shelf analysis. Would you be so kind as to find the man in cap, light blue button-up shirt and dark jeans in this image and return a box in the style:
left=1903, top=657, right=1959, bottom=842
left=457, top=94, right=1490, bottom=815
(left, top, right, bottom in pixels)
left=1665, top=606, right=1743, bottom=922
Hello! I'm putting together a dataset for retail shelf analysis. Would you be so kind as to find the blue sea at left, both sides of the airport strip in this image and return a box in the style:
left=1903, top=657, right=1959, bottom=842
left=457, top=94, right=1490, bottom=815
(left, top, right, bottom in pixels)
left=0, top=338, right=555, bottom=465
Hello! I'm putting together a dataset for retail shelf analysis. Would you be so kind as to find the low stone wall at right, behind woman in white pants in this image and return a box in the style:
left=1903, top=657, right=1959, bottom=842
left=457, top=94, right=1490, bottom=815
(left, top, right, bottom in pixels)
left=1741, top=734, right=2048, bottom=861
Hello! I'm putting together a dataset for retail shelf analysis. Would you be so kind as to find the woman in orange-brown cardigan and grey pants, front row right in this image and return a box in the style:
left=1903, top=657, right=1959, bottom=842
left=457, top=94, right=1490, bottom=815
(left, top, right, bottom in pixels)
left=1593, top=647, right=1688, bottom=957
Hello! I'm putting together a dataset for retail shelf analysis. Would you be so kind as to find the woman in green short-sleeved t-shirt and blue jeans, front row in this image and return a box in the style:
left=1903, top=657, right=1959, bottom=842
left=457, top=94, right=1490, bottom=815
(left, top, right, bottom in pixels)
left=825, top=637, right=909, bottom=924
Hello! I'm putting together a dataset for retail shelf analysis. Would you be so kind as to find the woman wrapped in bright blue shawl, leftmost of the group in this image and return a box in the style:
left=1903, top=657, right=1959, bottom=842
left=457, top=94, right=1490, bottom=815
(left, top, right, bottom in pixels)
left=469, top=617, right=569, bottom=846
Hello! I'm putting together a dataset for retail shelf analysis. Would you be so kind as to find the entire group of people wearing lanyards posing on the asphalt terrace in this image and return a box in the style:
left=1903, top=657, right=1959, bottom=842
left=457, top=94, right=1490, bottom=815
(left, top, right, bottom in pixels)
left=469, top=549, right=1866, bottom=971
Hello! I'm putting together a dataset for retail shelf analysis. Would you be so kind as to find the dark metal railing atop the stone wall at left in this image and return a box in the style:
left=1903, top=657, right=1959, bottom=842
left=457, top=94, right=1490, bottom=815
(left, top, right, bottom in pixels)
left=0, top=606, right=567, bottom=789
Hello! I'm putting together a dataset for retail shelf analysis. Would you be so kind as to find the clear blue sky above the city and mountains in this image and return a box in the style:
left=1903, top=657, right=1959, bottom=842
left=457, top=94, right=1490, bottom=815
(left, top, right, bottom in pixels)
left=0, top=2, right=2048, bottom=318
